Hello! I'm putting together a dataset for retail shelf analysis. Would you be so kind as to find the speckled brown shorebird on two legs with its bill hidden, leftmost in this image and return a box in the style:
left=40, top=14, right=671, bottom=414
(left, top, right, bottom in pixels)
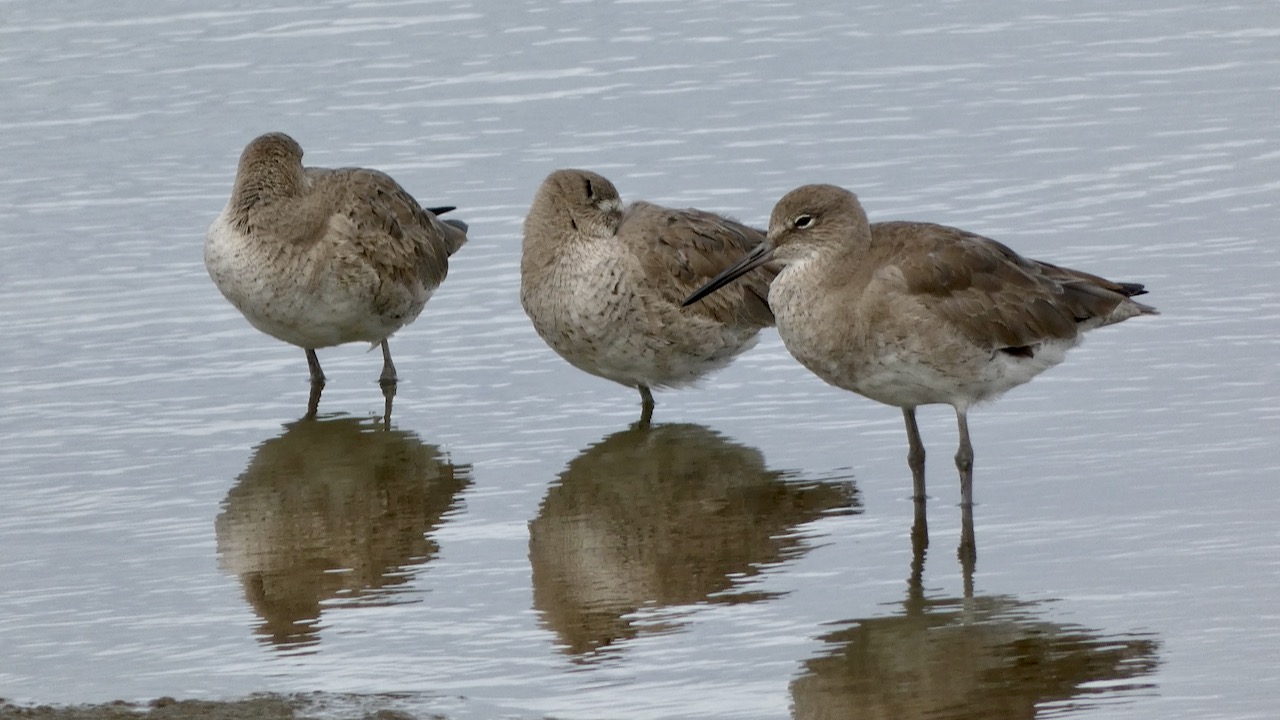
left=205, top=132, right=467, bottom=414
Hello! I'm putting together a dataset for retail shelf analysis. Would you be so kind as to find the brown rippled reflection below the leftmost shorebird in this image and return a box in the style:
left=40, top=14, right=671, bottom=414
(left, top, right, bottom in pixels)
left=215, top=418, right=471, bottom=651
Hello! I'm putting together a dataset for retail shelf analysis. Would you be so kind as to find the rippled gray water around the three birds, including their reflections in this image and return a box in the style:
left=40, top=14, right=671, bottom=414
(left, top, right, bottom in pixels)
left=0, top=0, right=1280, bottom=719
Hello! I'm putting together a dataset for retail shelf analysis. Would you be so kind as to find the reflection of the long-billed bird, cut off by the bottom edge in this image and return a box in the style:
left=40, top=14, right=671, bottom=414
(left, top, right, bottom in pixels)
left=791, top=517, right=1160, bottom=720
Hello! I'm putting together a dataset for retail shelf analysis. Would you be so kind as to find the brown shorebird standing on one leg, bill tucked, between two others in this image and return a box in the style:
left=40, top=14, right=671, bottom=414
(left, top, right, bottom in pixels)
left=520, top=169, right=773, bottom=423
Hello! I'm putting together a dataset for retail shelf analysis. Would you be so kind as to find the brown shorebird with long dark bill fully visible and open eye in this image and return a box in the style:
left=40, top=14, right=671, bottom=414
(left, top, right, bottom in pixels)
left=685, top=184, right=1156, bottom=507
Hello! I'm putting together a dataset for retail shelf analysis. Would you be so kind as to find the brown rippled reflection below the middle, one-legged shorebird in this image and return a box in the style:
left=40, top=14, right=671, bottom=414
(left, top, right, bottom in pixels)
left=529, top=423, right=860, bottom=661
